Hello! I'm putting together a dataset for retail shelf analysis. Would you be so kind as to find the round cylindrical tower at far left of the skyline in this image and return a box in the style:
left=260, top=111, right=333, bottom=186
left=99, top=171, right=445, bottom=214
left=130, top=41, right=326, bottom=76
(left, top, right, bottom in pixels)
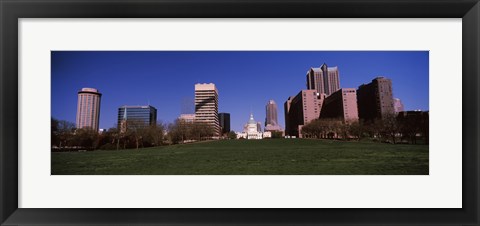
left=76, top=88, right=102, bottom=131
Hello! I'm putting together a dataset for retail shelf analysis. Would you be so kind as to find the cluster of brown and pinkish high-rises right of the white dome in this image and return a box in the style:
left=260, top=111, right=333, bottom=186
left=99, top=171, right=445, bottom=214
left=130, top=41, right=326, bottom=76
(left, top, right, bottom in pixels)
left=284, top=63, right=410, bottom=137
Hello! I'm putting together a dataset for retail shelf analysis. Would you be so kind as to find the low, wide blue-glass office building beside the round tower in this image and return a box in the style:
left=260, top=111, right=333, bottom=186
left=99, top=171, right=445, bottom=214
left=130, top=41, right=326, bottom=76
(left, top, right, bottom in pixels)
left=117, top=105, right=157, bottom=132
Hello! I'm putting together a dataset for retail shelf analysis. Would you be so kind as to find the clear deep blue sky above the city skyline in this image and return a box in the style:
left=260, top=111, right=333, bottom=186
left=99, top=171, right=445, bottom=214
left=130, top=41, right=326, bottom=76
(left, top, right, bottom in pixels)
left=51, top=51, right=429, bottom=131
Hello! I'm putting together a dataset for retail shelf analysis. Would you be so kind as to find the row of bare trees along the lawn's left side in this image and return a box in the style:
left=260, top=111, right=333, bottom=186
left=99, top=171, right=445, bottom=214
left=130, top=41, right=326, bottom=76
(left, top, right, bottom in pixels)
left=51, top=118, right=223, bottom=151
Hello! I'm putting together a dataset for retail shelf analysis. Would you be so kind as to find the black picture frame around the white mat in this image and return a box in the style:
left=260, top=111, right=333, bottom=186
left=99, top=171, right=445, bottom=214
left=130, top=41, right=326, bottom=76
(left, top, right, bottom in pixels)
left=0, top=0, right=480, bottom=225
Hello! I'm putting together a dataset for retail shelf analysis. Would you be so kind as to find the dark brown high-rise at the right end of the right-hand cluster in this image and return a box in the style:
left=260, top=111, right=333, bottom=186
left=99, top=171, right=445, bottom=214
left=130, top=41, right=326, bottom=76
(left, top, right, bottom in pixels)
left=357, top=77, right=395, bottom=122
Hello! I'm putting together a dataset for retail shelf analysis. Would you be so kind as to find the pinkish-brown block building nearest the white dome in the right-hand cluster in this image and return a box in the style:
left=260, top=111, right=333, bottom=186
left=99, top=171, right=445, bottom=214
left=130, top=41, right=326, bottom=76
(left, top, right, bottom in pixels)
left=285, top=90, right=320, bottom=138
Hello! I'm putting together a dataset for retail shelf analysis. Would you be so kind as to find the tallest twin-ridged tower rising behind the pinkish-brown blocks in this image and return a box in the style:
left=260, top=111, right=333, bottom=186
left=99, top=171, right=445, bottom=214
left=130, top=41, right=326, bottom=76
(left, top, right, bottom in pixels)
left=307, top=63, right=340, bottom=96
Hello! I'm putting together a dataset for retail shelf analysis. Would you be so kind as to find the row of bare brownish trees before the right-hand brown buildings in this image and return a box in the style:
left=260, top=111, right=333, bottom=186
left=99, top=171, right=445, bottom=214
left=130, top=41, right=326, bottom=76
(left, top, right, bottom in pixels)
left=301, top=112, right=429, bottom=144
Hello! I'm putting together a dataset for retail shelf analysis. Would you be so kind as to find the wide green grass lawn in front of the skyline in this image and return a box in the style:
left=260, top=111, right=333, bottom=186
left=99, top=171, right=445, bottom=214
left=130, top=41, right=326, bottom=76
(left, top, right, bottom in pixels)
left=52, top=139, right=429, bottom=175
